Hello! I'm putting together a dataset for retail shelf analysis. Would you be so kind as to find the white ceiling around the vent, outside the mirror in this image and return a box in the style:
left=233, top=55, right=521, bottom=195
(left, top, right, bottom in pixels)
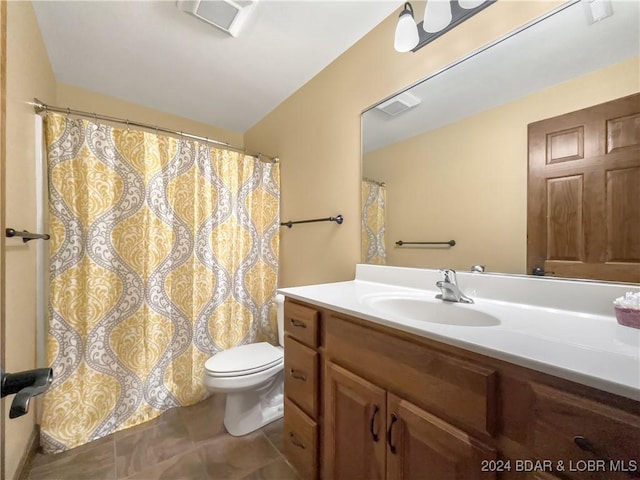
left=33, top=0, right=402, bottom=133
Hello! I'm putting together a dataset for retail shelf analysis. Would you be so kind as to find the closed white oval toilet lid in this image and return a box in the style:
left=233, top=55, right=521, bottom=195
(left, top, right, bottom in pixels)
left=204, top=342, right=284, bottom=377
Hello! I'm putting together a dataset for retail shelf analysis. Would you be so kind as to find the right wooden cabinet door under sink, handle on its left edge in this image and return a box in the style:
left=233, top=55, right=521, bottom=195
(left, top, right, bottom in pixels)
left=387, top=393, right=496, bottom=480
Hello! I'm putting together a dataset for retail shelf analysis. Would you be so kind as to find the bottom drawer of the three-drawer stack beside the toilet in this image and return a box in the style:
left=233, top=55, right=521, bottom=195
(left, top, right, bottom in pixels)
left=284, top=398, right=318, bottom=479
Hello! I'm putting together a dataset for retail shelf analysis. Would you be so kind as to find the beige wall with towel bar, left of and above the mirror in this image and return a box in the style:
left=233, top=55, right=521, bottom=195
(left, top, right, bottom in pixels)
left=245, top=1, right=561, bottom=286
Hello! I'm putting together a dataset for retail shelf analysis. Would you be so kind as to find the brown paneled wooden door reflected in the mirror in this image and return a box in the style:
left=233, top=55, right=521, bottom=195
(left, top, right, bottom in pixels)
left=527, top=94, right=640, bottom=282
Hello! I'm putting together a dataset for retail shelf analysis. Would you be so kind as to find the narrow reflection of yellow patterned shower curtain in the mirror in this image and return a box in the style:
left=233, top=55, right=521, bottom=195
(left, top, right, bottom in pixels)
left=361, top=179, right=387, bottom=265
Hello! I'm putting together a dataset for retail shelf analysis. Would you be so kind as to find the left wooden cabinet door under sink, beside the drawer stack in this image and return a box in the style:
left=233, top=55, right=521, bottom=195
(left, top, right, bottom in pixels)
left=323, top=362, right=386, bottom=480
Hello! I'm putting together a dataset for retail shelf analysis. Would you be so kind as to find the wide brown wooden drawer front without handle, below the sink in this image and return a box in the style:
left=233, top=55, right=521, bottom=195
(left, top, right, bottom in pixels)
left=324, top=316, right=497, bottom=435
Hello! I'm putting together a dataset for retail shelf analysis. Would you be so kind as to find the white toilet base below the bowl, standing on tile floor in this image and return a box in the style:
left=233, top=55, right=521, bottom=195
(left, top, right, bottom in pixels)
left=224, top=372, right=284, bottom=437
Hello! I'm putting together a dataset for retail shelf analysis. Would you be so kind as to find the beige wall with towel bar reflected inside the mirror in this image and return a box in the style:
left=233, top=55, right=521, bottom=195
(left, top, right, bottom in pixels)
left=363, top=58, right=640, bottom=273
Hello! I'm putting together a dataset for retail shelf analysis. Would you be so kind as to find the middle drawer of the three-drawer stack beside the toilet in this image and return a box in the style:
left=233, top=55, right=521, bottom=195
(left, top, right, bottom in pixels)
left=284, top=336, right=318, bottom=419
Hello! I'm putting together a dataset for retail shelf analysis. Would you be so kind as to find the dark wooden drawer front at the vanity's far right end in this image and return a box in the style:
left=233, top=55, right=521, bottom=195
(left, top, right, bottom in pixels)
left=528, top=384, right=640, bottom=479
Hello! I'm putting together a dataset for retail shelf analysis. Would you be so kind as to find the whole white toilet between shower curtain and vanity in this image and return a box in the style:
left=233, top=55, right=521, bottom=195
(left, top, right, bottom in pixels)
left=203, top=295, right=284, bottom=437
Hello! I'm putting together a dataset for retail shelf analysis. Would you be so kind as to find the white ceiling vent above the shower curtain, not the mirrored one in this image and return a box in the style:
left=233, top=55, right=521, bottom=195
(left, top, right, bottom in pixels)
left=177, top=0, right=257, bottom=37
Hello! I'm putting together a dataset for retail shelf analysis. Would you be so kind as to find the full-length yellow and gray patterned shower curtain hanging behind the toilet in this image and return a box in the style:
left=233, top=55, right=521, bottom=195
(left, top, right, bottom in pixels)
left=41, top=114, right=280, bottom=453
